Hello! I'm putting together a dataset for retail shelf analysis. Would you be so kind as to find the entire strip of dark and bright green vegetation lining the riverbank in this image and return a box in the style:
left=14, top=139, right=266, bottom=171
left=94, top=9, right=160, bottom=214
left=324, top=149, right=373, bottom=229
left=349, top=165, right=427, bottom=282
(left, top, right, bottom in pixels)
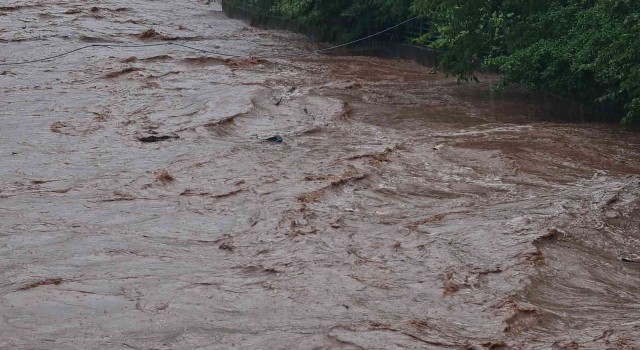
left=234, top=0, right=640, bottom=123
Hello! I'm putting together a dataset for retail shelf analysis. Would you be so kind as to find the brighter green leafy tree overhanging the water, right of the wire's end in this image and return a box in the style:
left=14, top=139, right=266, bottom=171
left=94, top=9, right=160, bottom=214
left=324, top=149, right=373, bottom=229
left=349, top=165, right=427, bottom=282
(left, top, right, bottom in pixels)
left=413, top=0, right=640, bottom=123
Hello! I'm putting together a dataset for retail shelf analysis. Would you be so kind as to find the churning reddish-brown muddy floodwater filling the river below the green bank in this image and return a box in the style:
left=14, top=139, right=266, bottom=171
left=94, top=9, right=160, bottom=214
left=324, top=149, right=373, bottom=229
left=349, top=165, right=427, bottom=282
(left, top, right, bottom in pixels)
left=0, top=0, right=640, bottom=350
